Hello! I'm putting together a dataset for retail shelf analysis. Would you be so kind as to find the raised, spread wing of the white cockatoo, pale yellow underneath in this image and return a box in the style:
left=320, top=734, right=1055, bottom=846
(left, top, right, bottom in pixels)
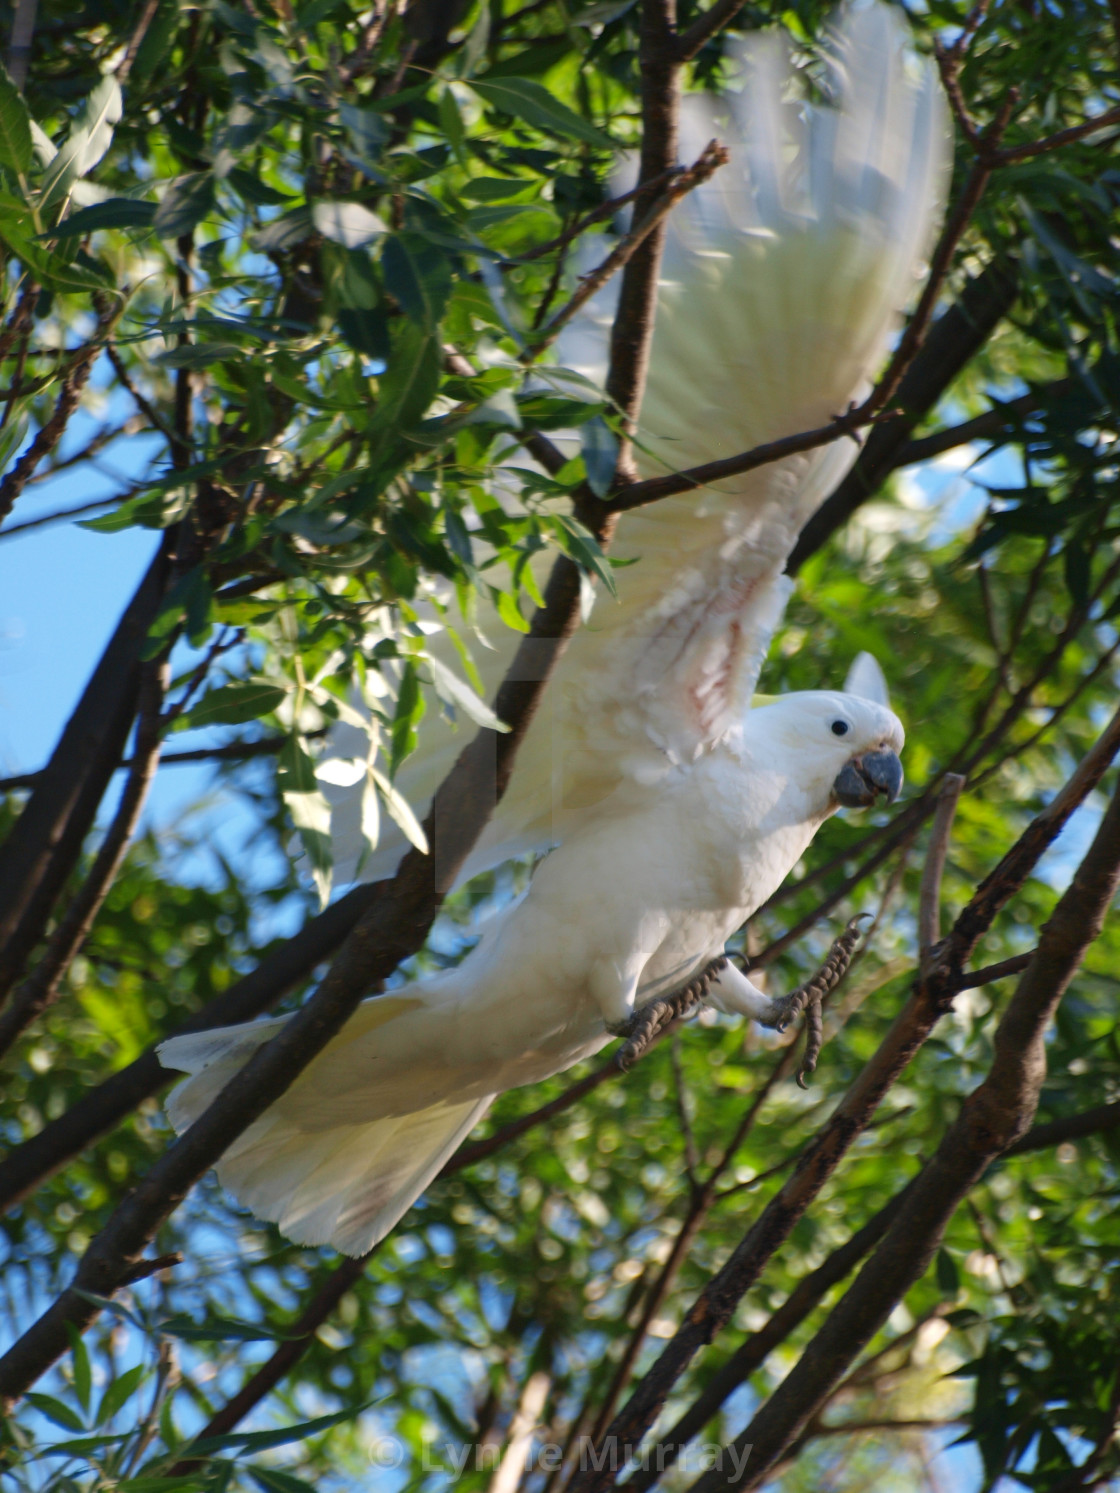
left=335, top=4, right=950, bottom=878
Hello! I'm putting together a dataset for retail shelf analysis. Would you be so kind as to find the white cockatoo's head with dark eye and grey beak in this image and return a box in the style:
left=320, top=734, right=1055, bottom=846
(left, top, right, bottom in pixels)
left=751, top=654, right=905, bottom=815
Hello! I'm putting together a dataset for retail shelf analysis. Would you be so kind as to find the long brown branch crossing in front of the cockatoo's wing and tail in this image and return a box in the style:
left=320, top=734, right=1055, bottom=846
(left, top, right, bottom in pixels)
left=0, top=0, right=692, bottom=1400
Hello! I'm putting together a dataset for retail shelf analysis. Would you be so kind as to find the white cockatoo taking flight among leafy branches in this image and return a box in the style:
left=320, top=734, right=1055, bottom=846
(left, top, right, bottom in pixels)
left=160, top=3, right=948, bottom=1254
